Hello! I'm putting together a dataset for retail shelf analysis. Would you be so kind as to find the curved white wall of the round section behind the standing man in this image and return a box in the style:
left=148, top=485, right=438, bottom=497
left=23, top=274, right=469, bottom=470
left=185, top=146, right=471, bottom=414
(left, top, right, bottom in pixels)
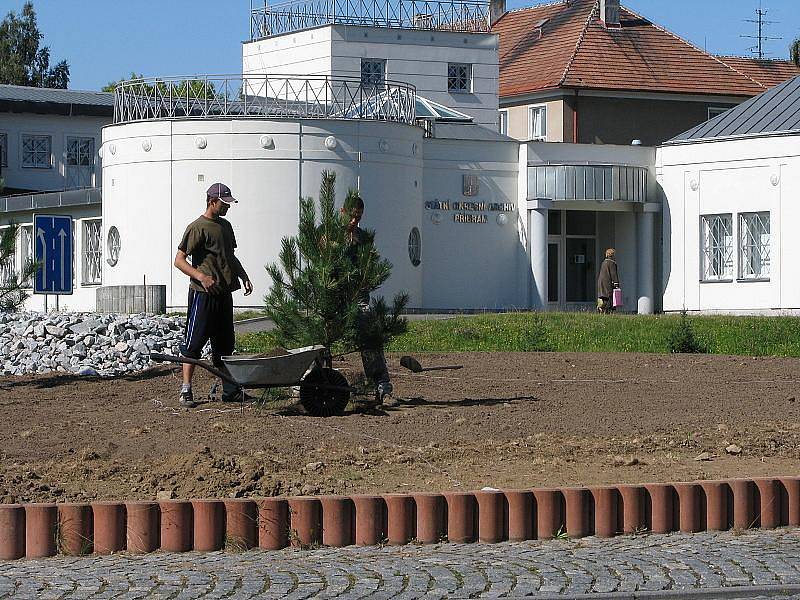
left=103, top=119, right=423, bottom=307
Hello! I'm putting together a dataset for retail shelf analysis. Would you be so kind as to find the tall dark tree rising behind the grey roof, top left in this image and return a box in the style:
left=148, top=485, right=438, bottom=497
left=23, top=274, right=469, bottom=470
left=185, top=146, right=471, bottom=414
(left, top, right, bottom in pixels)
left=0, top=2, right=69, bottom=89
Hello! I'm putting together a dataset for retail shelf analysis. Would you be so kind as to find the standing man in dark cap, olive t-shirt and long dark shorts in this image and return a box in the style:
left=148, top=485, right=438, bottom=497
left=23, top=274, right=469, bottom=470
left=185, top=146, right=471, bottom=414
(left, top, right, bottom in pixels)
left=175, top=183, right=253, bottom=408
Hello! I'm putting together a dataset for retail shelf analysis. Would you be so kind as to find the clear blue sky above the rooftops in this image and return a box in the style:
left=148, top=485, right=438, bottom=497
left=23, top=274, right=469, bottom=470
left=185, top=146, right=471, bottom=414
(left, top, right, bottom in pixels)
left=6, top=0, right=800, bottom=90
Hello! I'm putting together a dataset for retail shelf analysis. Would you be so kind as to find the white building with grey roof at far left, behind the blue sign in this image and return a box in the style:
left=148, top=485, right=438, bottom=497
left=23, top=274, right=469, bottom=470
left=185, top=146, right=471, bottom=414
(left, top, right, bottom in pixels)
left=0, top=85, right=114, bottom=310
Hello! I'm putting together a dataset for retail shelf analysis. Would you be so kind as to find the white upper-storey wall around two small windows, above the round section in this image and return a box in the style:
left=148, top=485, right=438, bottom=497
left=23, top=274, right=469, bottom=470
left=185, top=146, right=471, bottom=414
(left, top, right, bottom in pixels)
left=242, top=25, right=499, bottom=130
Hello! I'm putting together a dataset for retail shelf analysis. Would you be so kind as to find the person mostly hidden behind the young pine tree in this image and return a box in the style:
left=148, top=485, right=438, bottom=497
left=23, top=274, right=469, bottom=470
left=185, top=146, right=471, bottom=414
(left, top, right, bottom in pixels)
left=342, top=194, right=393, bottom=404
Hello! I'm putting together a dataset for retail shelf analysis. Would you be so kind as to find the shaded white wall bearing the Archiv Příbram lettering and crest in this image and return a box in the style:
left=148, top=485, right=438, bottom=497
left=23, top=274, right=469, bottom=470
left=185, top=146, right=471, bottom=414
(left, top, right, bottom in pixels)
left=422, top=138, right=530, bottom=309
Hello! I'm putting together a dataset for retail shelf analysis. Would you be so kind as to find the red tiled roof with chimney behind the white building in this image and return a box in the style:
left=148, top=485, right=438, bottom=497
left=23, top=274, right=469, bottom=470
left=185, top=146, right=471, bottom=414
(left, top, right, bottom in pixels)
left=492, top=0, right=797, bottom=97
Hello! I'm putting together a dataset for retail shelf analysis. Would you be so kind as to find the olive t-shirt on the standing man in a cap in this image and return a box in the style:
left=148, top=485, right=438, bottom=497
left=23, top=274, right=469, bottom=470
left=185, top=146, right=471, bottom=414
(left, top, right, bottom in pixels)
left=178, top=215, right=241, bottom=292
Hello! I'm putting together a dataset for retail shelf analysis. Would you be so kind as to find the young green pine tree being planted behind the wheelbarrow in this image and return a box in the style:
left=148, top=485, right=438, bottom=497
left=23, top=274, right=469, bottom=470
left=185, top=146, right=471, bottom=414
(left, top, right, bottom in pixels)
left=265, top=171, right=408, bottom=366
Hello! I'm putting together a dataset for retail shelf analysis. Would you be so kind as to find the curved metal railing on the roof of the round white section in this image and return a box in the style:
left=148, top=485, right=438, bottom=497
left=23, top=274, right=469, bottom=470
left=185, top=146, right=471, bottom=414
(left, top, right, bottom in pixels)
left=114, top=75, right=416, bottom=124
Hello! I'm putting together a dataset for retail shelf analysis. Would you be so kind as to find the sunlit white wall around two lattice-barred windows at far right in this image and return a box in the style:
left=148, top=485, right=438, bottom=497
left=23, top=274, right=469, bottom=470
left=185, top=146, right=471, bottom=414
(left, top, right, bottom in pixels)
left=657, top=135, right=800, bottom=312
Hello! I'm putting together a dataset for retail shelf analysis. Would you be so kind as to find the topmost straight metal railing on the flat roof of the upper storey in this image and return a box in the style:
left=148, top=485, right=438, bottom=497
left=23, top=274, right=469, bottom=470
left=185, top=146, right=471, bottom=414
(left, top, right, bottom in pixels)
left=250, top=0, right=489, bottom=40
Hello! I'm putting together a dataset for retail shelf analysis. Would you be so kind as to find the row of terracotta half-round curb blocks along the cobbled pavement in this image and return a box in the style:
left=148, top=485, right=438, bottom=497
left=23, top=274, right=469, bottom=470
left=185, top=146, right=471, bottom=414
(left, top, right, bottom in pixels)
left=0, top=477, right=800, bottom=560
